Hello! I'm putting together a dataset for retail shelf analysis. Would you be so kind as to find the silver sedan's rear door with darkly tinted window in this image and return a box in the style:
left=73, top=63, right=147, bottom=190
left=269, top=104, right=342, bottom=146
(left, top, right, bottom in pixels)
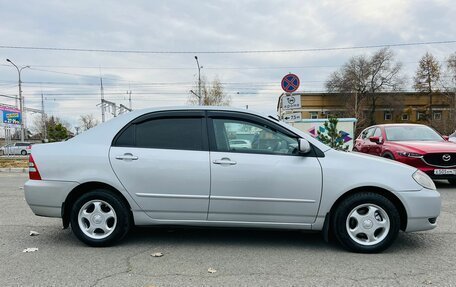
left=109, top=111, right=210, bottom=220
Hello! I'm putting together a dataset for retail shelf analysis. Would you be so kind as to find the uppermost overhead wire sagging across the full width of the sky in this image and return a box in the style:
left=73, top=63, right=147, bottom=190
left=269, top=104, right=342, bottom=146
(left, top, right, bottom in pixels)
left=0, top=40, right=456, bottom=54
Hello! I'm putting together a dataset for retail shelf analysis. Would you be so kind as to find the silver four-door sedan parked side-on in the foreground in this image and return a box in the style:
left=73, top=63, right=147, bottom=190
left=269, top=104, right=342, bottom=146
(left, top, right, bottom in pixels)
left=25, top=107, right=441, bottom=252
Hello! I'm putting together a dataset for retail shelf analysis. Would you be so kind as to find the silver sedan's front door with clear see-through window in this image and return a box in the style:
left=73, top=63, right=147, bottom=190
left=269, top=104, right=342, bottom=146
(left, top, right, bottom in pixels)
left=208, top=112, right=322, bottom=224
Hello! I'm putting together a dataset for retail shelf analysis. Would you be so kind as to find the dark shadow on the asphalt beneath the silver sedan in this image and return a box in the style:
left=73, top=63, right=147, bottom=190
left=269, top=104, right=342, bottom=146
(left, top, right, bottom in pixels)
left=40, top=226, right=439, bottom=254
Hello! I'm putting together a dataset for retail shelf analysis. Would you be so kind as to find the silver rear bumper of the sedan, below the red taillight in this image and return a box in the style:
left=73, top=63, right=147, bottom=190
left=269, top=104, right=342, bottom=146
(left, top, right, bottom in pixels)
left=24, top=180, right=78, bottom=217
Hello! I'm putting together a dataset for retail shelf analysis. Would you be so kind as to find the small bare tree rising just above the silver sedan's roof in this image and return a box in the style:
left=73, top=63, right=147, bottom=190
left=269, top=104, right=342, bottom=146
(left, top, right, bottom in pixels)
left=188, top=79, right=231, bottom=106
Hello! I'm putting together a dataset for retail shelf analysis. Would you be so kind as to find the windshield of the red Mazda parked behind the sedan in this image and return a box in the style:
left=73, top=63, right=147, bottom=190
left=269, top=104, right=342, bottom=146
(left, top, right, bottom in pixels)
left=385, top=126, right=444, bottom=141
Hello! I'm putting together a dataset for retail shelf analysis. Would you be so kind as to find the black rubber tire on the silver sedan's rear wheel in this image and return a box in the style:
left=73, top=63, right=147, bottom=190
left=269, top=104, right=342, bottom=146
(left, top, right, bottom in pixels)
left=70, top=189, right=132, bottom=247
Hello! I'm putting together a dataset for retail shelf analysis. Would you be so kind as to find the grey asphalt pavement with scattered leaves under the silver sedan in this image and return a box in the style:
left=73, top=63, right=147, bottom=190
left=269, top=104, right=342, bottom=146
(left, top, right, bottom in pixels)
left=0, top=173, right=456, bottom=286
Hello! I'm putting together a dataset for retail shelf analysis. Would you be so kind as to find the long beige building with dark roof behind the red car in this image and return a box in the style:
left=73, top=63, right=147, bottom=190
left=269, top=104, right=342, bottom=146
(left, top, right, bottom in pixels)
left=278, top=92, right=456, bottom=134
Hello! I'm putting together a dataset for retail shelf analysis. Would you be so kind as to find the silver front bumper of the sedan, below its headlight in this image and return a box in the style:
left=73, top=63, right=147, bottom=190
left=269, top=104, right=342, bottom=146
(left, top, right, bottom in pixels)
left=396, top=188, right=442, bottom=232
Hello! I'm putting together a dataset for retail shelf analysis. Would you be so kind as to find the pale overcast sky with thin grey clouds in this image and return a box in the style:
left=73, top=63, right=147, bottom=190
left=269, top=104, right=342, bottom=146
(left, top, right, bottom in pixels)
left=0, top=0, right=456, bottom=132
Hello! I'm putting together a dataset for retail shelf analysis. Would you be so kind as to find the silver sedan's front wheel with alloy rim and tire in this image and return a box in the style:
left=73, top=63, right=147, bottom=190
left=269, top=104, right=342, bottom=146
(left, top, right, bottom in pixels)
left=332, top=192, right=400, bottom=253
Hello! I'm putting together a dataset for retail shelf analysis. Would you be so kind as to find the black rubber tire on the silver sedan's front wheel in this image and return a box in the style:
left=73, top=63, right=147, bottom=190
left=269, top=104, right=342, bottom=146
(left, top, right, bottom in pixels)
left=332, top=192, right=400, bottom=253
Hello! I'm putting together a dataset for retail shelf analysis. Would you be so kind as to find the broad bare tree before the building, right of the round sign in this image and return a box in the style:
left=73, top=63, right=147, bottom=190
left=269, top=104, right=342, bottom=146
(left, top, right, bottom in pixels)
left=326, top=48, right=404, bottom=132
